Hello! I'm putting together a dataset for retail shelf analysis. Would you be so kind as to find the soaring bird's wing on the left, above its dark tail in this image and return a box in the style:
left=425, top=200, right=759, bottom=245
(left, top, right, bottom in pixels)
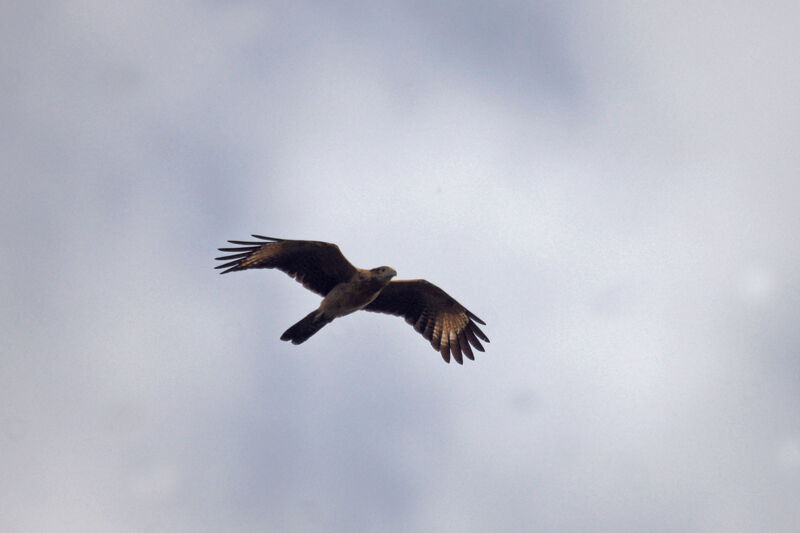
left=216, top=235, right=356, bottom=296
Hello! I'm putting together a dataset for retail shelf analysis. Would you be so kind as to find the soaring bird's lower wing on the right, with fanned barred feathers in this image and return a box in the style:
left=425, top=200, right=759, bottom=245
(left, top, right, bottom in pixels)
left=364, top=279, right=489, bottom=364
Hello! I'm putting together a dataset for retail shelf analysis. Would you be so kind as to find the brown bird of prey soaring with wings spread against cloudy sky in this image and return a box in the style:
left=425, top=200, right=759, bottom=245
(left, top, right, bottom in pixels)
left=215, top=234, right=489, bottom=364
